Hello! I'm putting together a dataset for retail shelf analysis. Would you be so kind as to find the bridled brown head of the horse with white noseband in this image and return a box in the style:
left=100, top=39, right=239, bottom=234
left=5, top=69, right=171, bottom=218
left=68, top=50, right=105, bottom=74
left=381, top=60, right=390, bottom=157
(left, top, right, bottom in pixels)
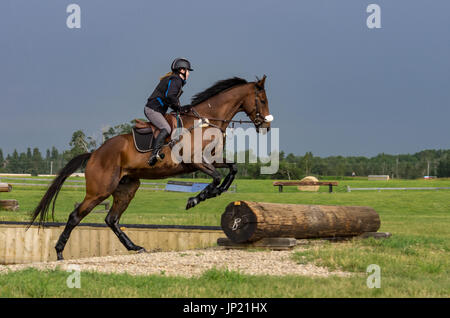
left=241, top=75, right=273, bottom=132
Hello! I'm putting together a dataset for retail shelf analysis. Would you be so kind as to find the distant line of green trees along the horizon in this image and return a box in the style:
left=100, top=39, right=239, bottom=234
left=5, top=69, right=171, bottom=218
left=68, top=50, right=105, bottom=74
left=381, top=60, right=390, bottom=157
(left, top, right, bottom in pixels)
left=0, top=128, right=450, bottom=180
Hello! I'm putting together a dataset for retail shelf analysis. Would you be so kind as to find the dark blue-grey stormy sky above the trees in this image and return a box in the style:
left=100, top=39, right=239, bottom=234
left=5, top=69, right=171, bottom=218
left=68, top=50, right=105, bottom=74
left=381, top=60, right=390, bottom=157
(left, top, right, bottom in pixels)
left=0, top=0, right=450, bottom=156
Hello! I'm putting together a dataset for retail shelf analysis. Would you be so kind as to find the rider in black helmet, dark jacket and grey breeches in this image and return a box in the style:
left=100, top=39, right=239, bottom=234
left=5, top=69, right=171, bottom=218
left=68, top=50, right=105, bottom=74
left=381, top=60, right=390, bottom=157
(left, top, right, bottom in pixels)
left=144, top=57, right=193, bottom=166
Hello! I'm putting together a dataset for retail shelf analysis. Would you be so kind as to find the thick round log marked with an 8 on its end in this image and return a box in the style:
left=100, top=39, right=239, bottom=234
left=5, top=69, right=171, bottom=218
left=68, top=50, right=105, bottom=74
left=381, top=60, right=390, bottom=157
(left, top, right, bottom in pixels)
left=221, top=201, right=380, bottom=243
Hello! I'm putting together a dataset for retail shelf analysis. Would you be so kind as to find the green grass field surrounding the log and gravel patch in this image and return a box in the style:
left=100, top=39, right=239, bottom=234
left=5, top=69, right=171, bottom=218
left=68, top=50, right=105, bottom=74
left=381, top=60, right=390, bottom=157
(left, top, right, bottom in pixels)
left=0, top=179, right=450, bottom=297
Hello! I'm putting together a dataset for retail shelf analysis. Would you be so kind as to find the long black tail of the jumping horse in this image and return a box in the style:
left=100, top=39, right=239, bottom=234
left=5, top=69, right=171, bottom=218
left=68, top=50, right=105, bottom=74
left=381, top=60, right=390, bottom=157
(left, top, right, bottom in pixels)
left=28, top=153, right=92, bottom=227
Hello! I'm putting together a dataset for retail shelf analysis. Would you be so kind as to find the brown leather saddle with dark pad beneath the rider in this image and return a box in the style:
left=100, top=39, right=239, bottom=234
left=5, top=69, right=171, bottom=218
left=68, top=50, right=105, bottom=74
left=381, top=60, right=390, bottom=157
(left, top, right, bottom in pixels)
left=132, top=113, right=183, bottom=152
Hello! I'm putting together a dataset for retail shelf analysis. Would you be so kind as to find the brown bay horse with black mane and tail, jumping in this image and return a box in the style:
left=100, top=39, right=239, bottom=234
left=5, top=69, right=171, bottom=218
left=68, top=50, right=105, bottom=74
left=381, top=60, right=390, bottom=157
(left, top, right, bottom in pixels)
left=30, top=75, right=273, bottom=260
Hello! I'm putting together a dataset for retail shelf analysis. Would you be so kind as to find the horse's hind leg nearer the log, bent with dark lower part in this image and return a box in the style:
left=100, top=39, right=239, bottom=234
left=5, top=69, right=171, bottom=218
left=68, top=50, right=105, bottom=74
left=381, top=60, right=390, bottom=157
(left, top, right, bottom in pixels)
left=105, top=176, right=145, bottom=252
